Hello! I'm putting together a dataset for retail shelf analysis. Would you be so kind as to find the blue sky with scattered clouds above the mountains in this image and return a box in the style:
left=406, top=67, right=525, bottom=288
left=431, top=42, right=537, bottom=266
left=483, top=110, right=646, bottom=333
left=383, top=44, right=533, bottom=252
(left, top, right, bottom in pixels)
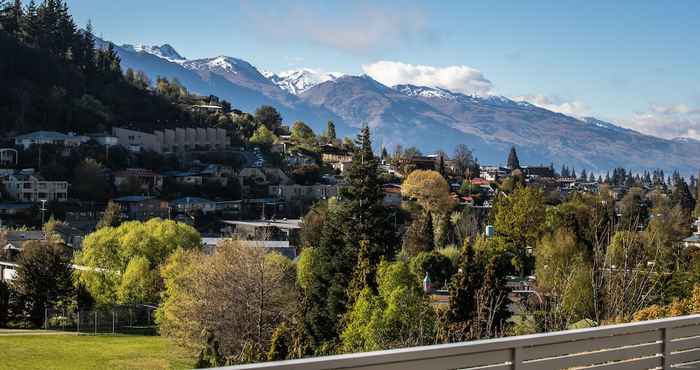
left=68, top=0, right=700, bottom=139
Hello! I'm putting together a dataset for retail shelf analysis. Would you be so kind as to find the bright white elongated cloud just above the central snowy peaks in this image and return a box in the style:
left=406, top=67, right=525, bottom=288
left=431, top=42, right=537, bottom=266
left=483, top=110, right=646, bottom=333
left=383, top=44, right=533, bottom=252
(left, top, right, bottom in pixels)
left=362, top=60, right=493, bottom=96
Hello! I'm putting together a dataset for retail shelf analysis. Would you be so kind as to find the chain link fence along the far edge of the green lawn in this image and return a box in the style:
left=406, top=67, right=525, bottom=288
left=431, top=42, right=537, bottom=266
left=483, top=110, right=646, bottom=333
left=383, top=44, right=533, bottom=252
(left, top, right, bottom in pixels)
left=44, top=305, right=156, bottom=335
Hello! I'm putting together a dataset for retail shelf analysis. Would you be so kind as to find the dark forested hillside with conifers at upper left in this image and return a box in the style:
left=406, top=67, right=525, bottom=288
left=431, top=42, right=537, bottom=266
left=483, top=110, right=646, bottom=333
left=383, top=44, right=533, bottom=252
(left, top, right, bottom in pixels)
left=0, top=0, right=230, bottom=137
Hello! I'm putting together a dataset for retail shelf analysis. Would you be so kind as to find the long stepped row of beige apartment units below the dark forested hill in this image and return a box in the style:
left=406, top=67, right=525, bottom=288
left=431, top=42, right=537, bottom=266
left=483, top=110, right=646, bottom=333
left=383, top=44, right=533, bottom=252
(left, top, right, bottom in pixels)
left=112, top=127, right=229, bottom=153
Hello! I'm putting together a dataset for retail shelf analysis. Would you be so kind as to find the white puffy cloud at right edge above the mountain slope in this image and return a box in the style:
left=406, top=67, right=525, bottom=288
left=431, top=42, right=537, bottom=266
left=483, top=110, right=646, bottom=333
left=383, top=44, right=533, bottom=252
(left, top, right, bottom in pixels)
left=621, top=104, right=700, bottom=140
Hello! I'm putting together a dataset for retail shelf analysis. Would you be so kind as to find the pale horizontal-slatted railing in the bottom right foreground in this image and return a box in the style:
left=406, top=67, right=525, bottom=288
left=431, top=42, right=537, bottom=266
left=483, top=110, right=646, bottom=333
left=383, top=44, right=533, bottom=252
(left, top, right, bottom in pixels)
left=221, top=315, right=700, bottom=370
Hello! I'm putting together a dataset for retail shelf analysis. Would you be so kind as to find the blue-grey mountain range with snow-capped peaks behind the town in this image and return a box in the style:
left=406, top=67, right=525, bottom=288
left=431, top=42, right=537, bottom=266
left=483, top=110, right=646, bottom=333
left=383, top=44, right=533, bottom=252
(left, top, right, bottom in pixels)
left=98, top=41, right=700, bottom=174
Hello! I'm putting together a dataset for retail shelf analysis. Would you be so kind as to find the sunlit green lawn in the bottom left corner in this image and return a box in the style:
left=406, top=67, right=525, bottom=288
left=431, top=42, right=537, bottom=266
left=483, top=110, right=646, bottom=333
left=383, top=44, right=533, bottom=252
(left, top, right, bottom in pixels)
left=0, top=334, right=195, bottom=370
